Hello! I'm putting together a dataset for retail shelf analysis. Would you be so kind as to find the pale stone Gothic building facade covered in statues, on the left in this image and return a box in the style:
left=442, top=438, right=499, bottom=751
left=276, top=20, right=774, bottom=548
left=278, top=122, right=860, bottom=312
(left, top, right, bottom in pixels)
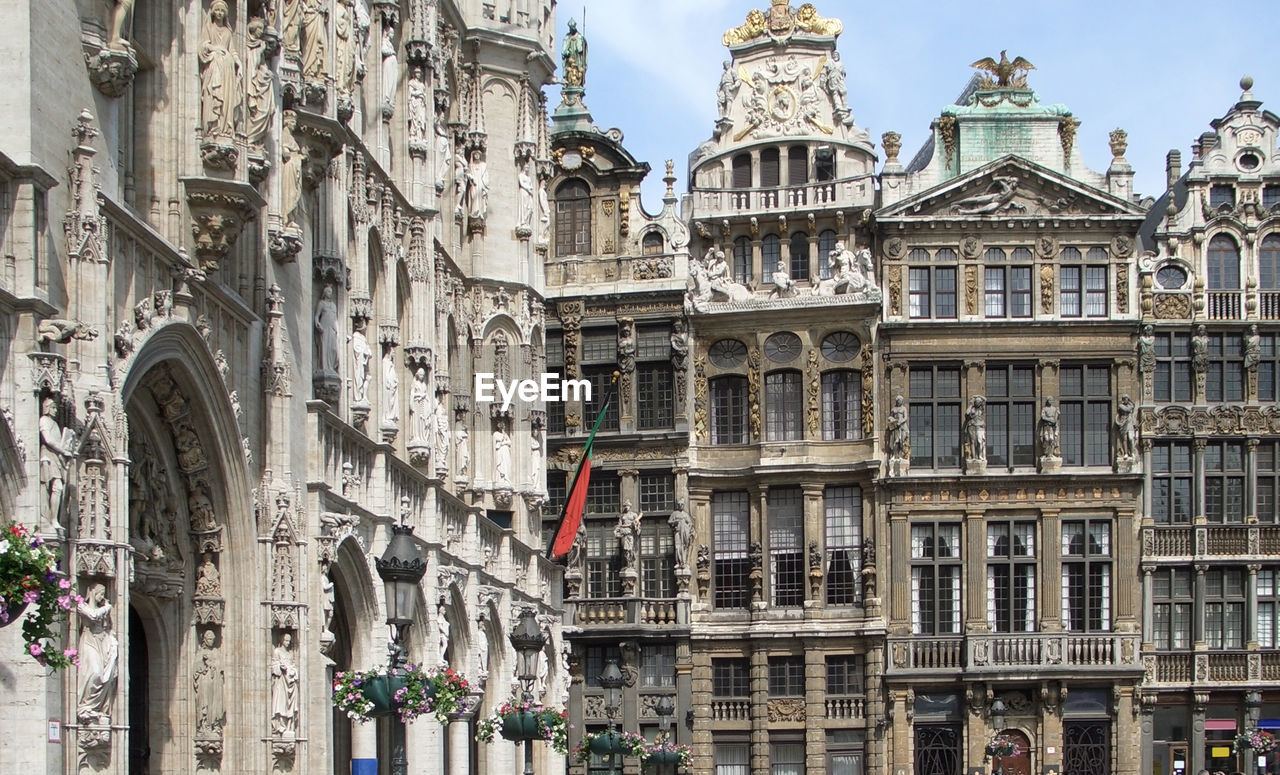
left=0, top=0, right=567, bottom=775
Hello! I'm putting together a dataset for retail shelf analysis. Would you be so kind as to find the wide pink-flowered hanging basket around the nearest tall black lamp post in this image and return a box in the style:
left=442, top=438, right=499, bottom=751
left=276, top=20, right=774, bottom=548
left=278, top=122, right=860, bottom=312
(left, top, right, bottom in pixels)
left=333, top=665, right=471, bottom=725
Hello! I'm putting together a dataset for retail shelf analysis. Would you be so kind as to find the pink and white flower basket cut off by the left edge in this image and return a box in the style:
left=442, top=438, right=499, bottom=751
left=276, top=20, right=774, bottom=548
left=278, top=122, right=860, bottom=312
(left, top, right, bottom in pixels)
left=0, top=523, right=84, bottom=670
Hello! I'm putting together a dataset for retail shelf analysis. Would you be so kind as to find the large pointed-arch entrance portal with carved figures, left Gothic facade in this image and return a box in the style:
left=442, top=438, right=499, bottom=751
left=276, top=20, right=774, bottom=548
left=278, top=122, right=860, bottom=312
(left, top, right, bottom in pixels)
left=114, top=338, right=253, bottom=775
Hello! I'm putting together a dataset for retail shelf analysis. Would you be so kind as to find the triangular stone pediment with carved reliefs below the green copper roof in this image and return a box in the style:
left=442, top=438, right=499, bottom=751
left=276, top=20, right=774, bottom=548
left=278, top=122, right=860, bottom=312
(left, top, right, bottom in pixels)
left=876, top=156, right=1144, bottom=220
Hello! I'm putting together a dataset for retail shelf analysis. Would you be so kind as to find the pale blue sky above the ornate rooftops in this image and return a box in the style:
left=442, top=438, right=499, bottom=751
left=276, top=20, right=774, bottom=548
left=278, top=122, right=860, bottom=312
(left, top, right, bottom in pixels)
left=549, top=0, right=1280, bottom=213
